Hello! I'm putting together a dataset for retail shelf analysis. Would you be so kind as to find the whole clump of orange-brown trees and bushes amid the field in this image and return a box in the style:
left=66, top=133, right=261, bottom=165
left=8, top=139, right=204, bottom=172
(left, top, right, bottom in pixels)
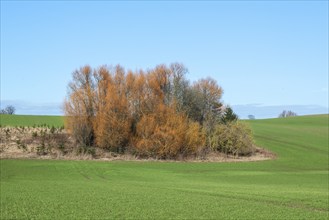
left=64, top=63, right=253, bottom=159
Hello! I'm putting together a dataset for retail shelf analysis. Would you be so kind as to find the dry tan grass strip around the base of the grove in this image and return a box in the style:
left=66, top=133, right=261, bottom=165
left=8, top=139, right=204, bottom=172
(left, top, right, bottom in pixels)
left=0, top=127, right=276, bottom=162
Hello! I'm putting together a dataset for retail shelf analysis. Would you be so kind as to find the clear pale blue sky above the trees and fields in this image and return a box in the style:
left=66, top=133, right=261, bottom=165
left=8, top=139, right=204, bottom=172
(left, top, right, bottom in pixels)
left=0, top=1, right=328, bottom=118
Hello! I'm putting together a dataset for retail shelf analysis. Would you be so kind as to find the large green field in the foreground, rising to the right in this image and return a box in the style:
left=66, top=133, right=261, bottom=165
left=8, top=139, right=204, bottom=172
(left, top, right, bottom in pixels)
left=0, top=115, right=329, bottom=219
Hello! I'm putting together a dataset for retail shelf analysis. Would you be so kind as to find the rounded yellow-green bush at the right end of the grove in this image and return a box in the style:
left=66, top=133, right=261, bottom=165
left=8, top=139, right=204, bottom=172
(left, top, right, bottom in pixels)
left=210, top=122, right=254, bottom=156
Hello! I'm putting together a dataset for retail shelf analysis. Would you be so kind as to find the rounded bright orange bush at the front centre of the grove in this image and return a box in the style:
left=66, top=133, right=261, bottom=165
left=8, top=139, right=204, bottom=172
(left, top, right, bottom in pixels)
left=135, top=107, right=205, bottom=159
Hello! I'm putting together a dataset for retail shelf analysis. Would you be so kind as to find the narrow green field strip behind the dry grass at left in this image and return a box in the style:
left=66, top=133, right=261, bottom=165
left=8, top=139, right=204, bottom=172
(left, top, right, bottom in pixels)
left=0, top=115, right=64, bottom=127
